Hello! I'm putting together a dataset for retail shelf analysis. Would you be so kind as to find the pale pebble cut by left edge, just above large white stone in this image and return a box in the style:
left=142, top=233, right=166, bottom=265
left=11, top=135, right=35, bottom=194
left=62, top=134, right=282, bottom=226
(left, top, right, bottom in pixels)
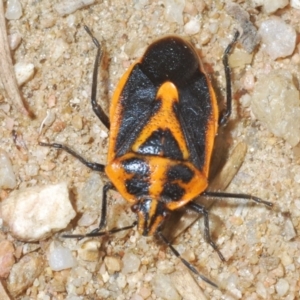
left=0, top=149, right=17, bottom=189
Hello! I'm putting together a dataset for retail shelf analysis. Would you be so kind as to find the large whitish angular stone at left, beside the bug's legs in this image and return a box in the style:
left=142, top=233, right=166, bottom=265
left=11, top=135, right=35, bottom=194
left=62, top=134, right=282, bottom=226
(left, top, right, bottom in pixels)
left=1, top=183, right=76, bottom=242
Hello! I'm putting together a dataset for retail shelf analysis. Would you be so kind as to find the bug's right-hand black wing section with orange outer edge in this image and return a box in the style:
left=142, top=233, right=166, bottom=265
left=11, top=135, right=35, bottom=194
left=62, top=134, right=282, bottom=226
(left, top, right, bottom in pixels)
left=176, top=69, right=218, bottom=173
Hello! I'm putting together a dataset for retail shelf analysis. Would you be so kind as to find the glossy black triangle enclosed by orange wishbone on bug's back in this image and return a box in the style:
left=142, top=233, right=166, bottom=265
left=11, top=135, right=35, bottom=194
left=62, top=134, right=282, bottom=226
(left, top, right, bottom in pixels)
left=138, top=128, right=183, bottom=160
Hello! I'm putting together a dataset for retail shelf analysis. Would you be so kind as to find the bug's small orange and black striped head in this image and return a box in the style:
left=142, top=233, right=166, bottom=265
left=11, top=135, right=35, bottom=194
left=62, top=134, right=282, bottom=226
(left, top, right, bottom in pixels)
left=131, top=198, right=170, bottom=236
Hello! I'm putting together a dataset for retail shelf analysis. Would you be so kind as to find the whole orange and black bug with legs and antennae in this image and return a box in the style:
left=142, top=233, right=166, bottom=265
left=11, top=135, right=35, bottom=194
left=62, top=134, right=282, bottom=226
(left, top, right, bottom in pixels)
left=40, top=27, right=272, bottom=287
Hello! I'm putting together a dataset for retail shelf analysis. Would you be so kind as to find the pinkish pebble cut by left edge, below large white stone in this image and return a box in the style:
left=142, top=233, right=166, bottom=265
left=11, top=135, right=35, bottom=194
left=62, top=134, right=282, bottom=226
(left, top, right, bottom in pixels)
left=0, top=240, right=15, bottom=278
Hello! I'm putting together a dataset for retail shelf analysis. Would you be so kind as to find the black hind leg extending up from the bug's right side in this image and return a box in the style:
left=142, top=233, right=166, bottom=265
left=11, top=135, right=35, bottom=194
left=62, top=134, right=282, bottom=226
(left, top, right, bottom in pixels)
left=219, top=31, right=240, bottom=125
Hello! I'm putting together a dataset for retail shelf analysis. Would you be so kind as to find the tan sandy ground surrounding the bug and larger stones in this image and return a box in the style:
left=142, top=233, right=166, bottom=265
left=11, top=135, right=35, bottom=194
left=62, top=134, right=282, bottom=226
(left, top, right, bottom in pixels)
left=0, top=1, right=300, bottom=300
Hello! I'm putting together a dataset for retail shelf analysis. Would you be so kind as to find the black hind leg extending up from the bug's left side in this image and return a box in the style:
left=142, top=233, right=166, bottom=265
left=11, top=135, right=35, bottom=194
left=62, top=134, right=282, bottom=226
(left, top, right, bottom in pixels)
left=84, top=25, right=109, bottom=129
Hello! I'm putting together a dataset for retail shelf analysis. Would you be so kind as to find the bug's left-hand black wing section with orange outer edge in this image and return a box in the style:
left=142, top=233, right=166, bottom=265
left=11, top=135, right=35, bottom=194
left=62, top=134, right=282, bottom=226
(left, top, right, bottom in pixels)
left=110, top=63, right=160, bottom=157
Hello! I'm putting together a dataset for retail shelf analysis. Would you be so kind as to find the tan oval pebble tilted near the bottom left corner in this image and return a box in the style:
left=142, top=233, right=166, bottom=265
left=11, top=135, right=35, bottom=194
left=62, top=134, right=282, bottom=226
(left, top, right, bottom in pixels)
left=7, top=253, right=44, bottom=297
